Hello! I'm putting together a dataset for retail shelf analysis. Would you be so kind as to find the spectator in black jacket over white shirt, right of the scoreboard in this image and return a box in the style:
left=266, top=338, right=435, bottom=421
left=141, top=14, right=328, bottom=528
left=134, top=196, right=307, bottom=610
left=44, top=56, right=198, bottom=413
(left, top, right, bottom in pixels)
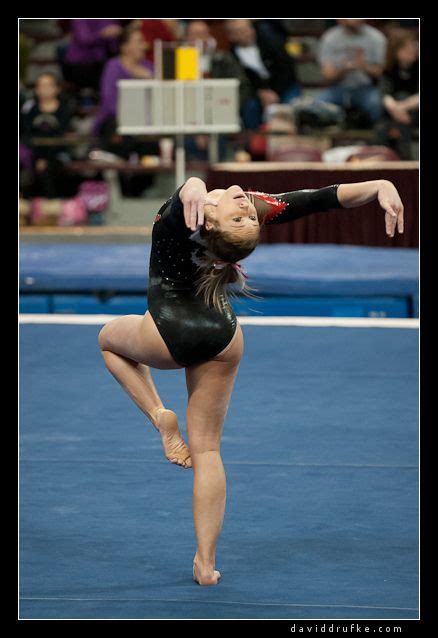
left=225, top=19, right=301, bottom=129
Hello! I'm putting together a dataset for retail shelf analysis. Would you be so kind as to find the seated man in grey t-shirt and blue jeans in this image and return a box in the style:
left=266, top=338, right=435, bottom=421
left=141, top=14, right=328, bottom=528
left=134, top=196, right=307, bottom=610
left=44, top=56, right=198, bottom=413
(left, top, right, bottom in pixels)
left=317, top=18, right=386, bottom=124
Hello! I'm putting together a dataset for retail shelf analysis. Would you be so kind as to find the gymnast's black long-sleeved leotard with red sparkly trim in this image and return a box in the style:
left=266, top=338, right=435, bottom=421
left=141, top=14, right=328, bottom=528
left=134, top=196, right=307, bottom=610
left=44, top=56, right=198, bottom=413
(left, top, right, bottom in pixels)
left=148, top=185, right=341, bottom=367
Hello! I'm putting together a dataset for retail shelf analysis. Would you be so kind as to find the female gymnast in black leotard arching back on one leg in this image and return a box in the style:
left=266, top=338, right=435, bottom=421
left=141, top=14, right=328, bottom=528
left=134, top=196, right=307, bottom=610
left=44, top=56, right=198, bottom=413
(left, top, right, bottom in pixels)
left=99, top=177, right=403, bottom=585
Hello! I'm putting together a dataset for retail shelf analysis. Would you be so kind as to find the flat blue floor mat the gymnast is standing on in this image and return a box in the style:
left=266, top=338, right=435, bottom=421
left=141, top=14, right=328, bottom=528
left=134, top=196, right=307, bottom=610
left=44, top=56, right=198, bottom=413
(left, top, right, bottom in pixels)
left=20, top=324, right=418, bottom=619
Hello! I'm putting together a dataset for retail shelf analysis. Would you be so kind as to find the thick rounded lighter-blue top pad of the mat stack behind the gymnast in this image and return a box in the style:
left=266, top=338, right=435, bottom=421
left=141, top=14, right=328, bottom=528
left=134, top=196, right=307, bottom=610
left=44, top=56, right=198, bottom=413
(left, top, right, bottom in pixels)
left=20, top=244, right=418, bottom=297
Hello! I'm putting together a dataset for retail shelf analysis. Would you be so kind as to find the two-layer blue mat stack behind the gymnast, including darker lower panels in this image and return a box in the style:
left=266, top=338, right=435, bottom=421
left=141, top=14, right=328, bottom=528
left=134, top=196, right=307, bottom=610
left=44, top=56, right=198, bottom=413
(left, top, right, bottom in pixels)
left=20, top=244, right=418, bottom=317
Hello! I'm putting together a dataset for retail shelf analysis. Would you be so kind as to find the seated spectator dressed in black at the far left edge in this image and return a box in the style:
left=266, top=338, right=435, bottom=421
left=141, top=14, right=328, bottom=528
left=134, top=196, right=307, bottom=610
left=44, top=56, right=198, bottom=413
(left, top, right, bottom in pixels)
left=21, top=73, right=77, bottom=198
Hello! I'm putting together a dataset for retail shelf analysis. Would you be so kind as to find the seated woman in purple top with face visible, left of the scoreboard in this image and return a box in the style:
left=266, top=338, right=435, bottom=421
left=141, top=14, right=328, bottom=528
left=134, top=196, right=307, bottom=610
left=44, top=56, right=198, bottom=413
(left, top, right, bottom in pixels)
left=93, top=26, right=159, bottom=196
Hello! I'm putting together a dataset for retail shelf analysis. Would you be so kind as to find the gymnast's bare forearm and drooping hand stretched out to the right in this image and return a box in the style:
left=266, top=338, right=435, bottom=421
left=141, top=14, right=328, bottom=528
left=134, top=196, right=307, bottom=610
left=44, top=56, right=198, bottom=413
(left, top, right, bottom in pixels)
left=337, top=179, right=404, bottom=237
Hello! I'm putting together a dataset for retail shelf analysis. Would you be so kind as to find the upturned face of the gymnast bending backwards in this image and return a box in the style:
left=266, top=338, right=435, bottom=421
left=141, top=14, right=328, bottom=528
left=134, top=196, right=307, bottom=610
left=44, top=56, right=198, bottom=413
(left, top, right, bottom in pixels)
left=205, top=186, right=260, bottom=244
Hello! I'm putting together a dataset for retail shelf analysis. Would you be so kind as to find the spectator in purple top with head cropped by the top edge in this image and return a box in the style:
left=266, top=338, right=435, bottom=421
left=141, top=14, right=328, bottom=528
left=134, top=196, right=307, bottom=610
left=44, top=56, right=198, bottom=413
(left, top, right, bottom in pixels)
left=61, top=19, right=122, bottom=91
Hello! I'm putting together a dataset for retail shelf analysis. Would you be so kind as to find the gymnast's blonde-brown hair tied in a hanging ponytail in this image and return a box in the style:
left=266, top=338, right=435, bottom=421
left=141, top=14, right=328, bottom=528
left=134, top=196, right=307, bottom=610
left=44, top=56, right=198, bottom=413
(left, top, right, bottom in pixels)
left=195, top=196, right=261, bottom=312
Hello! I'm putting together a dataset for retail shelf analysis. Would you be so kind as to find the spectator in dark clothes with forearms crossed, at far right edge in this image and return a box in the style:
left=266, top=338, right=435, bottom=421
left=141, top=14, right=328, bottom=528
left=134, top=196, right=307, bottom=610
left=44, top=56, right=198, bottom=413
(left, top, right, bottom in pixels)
left=378, top=29, right=419, bottom=160
